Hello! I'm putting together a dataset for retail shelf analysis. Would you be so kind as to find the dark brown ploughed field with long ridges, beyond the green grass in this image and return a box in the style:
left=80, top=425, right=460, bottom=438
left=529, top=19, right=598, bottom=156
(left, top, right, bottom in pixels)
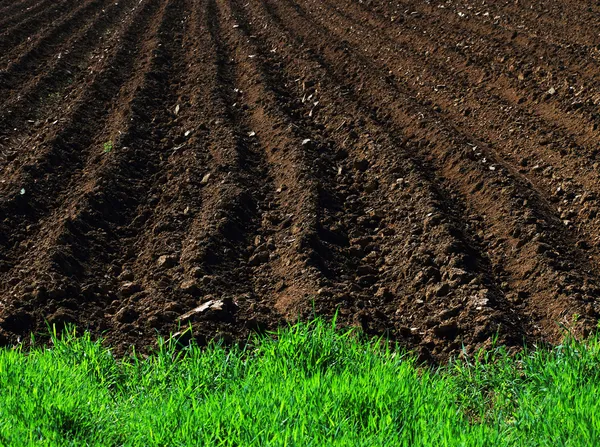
left=0, top=0, right=600, bottom=359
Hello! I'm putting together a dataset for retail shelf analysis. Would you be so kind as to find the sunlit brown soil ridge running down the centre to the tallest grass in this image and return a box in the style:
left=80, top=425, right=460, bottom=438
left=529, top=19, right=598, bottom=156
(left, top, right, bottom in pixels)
left=211, top=2, right=327, bottom=318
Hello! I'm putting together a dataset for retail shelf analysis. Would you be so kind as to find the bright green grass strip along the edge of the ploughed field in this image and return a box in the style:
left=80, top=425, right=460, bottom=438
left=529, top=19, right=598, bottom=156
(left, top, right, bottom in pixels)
left=0, top=320, right=600, bottom=447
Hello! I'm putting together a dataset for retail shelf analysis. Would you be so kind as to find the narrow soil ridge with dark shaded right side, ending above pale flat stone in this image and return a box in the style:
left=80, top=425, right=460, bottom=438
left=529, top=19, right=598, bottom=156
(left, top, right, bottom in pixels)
left=176, top=0, right=270, bottom=301
